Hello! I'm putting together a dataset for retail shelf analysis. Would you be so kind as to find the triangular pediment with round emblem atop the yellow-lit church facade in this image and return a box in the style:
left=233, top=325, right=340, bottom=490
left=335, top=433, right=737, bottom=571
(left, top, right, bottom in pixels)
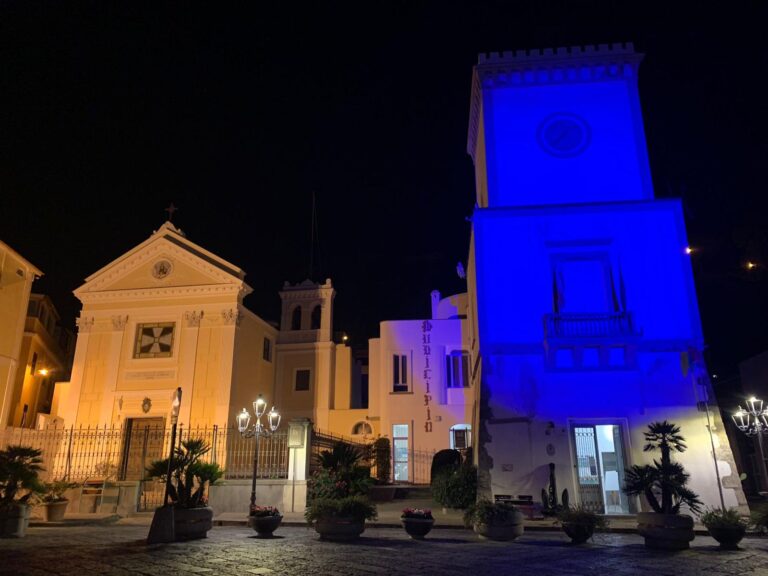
left=75, top=222, right=250, bottom=298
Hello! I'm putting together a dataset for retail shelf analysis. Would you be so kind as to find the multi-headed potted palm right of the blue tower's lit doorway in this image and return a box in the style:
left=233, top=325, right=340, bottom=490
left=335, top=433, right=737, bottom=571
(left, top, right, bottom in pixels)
left=624, top=420, right=701, bottom=550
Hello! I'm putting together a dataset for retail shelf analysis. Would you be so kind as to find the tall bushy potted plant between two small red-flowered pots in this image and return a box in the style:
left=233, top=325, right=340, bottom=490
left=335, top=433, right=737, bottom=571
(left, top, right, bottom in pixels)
left=304, top=442, right=376, bottom=540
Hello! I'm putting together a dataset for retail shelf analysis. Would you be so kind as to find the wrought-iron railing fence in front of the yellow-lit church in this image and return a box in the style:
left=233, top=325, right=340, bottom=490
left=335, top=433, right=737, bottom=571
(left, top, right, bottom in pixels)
left=0, top=425, right=288, bottom=482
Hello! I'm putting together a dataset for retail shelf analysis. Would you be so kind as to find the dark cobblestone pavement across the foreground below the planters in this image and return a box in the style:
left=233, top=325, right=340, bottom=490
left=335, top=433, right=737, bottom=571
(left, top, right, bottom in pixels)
left=0, top=524, right=768, bottom=576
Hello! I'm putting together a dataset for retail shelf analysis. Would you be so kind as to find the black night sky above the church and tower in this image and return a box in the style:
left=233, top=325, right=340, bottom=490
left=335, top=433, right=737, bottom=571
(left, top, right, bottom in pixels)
left=0, top=0, right=768, bottom=382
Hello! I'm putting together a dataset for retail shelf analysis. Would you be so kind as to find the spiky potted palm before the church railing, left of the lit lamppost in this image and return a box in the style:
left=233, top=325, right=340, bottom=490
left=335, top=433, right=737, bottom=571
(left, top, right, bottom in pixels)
left=147, top=439, right=224, bottom=540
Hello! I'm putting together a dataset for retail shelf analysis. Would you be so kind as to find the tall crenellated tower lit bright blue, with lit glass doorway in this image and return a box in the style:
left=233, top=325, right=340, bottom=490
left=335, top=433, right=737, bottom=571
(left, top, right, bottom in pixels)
left=468, top=44, right=744, bottom=514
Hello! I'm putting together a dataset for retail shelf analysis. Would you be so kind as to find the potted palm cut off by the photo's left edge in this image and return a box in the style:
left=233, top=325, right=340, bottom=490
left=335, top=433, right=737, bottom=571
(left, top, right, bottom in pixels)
left=0, top=445, right=43, bottom=538
